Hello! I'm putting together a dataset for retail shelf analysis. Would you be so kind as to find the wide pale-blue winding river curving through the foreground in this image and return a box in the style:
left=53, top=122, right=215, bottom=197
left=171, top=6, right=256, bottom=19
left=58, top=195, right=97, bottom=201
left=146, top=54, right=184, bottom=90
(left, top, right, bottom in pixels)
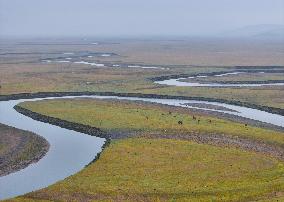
left=0, top=95, right=284, bottom=199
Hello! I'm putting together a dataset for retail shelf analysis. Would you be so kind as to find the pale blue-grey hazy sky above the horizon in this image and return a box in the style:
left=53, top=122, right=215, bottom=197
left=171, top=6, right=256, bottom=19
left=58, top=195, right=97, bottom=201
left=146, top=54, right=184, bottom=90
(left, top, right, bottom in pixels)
left=0, top=0, right=284, bottom=36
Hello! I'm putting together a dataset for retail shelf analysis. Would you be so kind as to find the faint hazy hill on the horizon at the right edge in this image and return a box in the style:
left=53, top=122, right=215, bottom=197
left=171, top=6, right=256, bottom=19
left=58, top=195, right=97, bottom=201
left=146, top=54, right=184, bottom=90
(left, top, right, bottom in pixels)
left=219, top=24, right=284, bottom=40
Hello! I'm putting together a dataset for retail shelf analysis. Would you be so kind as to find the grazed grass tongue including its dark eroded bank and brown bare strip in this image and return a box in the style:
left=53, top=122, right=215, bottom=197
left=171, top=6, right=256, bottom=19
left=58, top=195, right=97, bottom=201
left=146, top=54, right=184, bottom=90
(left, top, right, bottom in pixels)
left=14, top=98, right=284, bottom=160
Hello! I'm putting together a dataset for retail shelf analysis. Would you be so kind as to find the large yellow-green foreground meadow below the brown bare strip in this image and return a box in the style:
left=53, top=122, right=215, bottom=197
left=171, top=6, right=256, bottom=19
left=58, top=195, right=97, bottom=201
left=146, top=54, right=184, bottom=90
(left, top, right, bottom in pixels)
left=13, top=138, right=284, bottom=201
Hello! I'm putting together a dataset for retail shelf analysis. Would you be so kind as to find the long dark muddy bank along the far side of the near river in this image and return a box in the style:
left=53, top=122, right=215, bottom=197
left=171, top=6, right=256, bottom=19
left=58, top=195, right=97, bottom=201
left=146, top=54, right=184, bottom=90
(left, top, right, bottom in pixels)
left=0, top=91, right=284, bottom=116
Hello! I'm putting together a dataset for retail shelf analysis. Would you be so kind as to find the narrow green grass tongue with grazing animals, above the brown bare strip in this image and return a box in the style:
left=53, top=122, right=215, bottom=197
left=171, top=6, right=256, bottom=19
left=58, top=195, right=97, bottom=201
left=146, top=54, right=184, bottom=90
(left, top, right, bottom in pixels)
left=20, top=99, right=284, bottom=148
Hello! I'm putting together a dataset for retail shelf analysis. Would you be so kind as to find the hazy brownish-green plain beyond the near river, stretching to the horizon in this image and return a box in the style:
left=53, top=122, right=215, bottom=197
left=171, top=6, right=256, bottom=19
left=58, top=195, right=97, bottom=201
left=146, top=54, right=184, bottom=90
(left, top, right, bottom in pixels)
left=0, top=40, right=284, bottom=109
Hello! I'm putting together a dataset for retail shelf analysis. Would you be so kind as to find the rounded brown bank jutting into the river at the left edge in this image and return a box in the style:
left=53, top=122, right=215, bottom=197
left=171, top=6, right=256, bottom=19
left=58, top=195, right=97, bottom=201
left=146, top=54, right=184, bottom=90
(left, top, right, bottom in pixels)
left=0, top=124, right=50, bottom=177
